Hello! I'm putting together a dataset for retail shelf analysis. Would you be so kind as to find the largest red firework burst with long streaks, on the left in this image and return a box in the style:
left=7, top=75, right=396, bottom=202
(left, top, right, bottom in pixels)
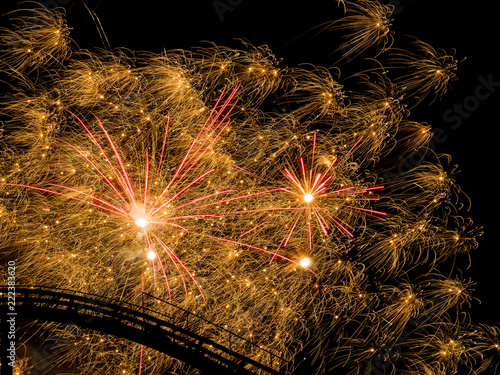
left=2, top=87, right=302, bottom=300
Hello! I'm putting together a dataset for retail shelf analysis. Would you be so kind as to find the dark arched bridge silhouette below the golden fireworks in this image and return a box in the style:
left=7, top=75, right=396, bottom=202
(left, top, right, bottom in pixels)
left=0, top=286, right=290, bottom=375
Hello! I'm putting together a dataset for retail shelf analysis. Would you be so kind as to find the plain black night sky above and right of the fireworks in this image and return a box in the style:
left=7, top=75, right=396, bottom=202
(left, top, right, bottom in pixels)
left=0, top=0, right=500, bottom=354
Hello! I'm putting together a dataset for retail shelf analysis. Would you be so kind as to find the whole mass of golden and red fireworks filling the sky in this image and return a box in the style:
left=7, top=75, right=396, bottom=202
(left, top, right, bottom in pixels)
left=0, top=1, right=500, bottom=375
